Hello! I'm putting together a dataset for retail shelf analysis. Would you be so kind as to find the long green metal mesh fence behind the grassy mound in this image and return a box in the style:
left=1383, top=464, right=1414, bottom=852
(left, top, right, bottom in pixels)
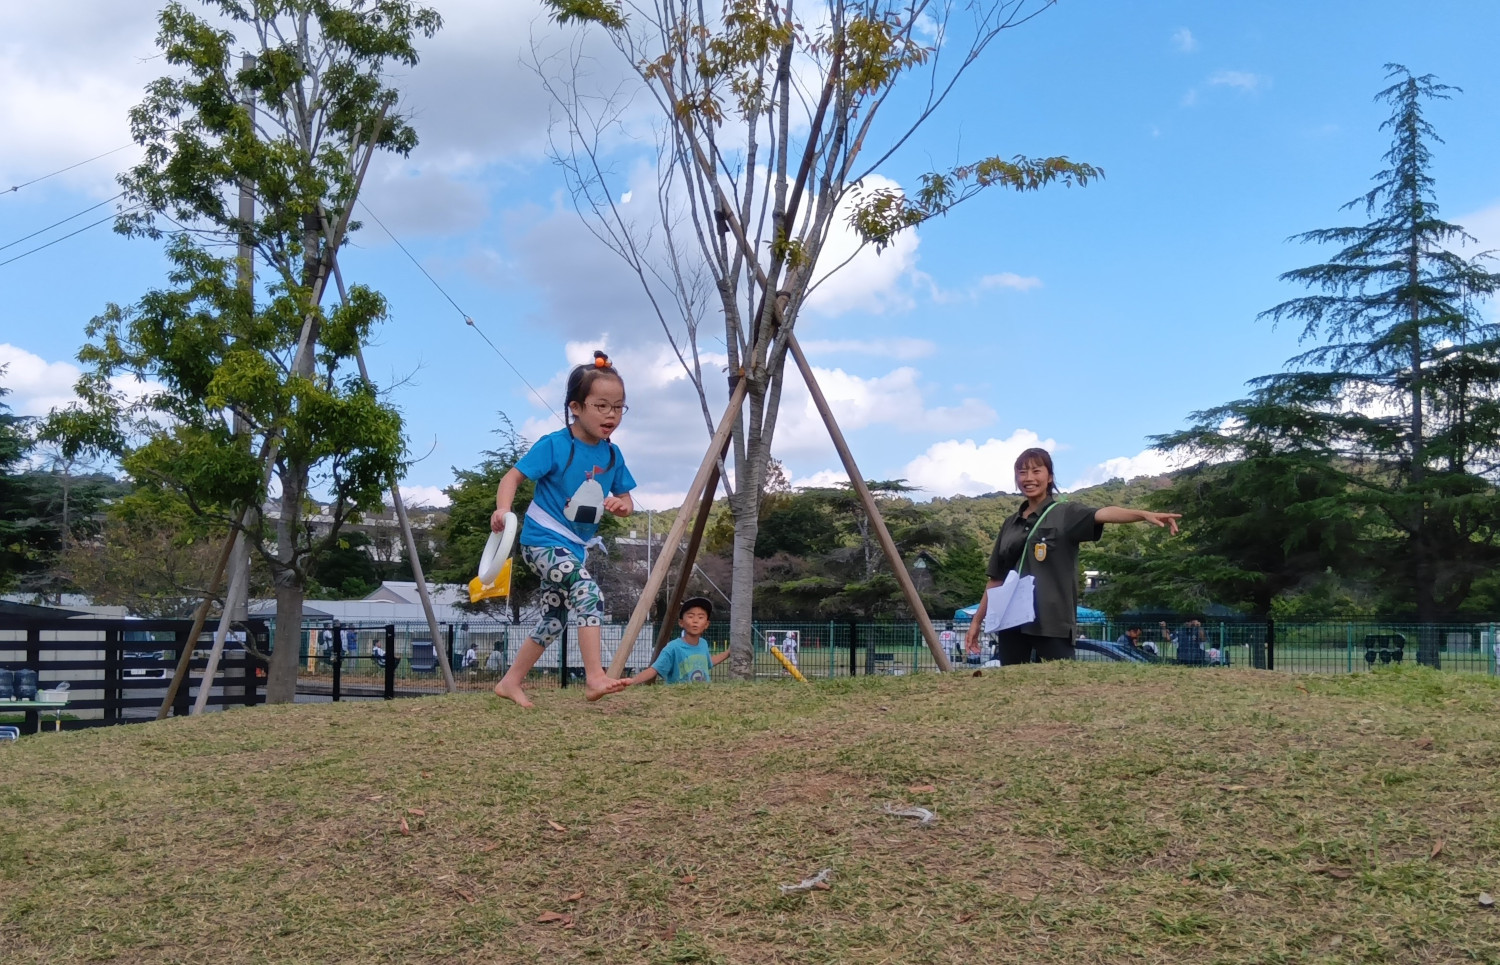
left=283, top=621, right=1500, bottom=698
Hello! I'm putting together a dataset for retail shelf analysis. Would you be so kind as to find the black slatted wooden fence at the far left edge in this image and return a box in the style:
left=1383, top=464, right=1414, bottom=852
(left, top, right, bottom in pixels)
left=0, top=617, right=270, bottom=734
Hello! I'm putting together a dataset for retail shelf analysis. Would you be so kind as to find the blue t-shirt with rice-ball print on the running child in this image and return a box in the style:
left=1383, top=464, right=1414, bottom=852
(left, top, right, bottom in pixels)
left=516, top=429, right=636, bottom=552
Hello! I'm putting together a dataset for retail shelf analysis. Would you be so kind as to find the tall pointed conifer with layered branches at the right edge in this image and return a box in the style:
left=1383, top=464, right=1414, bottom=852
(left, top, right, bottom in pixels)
left=1160, top=65, right=1500, bottom=665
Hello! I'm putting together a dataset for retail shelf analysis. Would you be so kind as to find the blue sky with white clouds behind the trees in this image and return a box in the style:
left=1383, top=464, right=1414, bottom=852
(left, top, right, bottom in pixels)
left=0, top=0, right=1500, bottom=507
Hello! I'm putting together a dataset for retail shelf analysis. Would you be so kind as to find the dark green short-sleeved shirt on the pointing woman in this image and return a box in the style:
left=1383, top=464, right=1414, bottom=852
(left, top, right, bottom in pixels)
left=987, top=500, right=1104, bottom=641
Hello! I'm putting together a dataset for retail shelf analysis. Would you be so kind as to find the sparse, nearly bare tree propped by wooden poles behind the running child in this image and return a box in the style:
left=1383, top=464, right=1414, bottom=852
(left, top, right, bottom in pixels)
left=537, top=0, right=1100, bottom=677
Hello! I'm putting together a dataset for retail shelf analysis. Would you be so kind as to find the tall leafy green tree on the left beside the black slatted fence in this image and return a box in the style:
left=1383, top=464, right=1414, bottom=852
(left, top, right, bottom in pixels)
left=50, top=0, right=441, bottom=702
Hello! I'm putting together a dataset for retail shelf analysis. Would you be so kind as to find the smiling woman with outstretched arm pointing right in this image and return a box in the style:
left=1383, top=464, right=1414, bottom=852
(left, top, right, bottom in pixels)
left=968, top=449, right=1182, bottom=665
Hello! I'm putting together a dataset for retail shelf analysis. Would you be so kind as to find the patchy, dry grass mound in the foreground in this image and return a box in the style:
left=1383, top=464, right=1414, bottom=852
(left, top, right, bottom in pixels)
left=0, top=665, right=1500, bottom=965
